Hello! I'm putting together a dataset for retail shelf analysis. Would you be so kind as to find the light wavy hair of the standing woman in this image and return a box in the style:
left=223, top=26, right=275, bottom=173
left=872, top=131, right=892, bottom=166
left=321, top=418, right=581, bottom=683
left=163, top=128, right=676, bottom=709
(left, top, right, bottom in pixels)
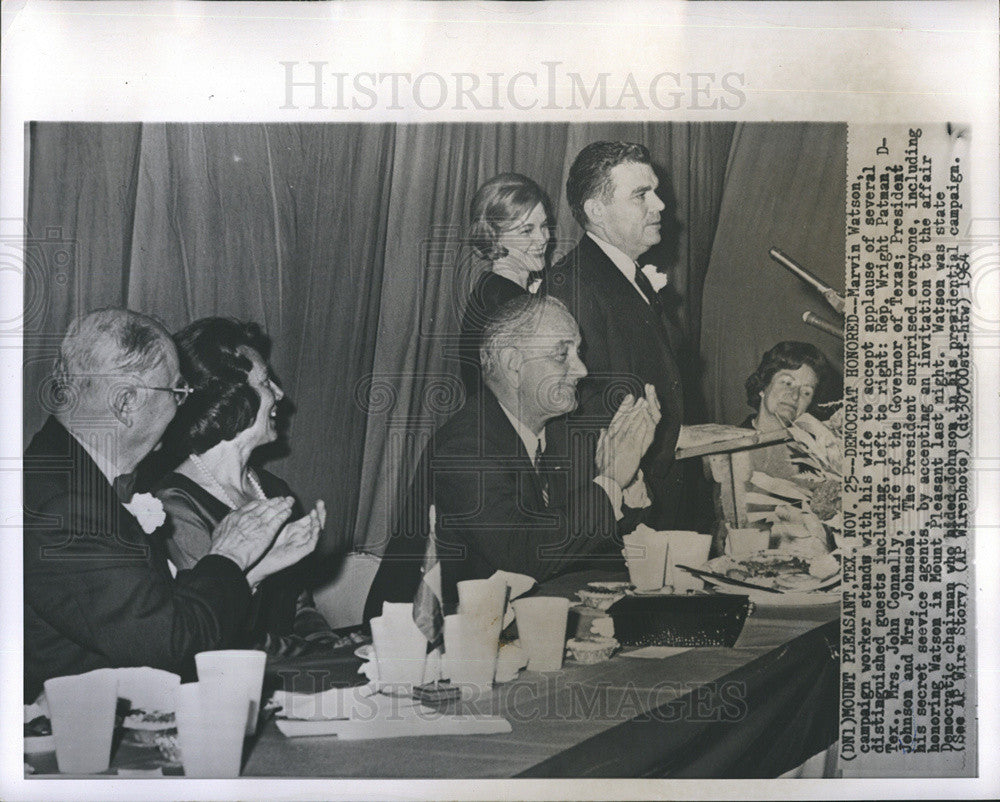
left=468, top=173, right=552, bottom=262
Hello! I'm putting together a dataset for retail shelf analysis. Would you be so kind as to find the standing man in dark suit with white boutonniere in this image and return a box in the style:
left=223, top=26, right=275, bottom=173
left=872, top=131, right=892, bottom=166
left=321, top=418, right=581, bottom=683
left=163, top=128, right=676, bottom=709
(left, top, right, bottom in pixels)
left=548, top=142, right=684, bottom=528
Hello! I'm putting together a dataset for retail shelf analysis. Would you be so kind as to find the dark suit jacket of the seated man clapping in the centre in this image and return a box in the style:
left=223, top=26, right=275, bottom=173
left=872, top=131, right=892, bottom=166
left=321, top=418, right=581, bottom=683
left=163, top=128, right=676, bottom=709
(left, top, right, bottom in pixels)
left=365, top=389, right=635, bottom=621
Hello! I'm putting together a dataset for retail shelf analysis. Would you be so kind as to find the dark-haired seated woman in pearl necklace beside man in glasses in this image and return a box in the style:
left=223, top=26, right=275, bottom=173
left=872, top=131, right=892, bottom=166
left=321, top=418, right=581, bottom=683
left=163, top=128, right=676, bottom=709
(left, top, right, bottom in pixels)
left=155, top=317, right=337, bottom=656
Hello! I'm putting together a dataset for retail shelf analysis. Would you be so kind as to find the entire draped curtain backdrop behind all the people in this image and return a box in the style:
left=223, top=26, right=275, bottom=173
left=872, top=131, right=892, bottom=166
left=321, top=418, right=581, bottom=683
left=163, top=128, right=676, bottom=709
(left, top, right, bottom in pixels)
left=24, top=123, right=843, bottom=553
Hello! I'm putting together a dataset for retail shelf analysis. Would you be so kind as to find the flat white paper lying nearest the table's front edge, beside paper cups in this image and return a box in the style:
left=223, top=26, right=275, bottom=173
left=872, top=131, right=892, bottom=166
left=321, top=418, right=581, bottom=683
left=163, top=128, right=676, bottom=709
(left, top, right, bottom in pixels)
left=276, top=708, right=511, bottom=741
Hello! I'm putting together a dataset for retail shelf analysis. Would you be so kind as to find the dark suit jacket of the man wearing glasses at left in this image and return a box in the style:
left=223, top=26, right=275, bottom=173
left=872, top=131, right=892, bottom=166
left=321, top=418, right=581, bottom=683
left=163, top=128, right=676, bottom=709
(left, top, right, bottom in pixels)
left=24, top=418, right=250, bottom=701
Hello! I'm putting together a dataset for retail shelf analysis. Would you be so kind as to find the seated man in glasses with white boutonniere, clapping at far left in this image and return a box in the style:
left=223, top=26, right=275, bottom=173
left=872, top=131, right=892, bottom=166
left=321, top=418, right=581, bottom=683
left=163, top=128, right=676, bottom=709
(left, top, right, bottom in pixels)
left=24, top=309, right=319, bottom=701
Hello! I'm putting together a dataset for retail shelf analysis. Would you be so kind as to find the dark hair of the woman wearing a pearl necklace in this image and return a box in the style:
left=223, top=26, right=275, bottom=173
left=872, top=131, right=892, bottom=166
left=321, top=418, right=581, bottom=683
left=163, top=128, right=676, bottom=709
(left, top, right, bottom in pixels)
left=164, top=317, right=271, bottom=455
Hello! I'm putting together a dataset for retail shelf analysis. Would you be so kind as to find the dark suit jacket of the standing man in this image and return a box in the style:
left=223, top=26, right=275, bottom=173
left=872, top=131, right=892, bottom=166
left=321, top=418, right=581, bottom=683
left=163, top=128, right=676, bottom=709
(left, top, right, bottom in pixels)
left=547, top=235, right=684, bottom=528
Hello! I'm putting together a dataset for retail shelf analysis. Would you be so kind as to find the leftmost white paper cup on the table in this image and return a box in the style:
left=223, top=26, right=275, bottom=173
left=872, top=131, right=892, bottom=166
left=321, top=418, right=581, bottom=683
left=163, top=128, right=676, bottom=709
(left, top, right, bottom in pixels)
left=45, top=668, right=118, bottom=774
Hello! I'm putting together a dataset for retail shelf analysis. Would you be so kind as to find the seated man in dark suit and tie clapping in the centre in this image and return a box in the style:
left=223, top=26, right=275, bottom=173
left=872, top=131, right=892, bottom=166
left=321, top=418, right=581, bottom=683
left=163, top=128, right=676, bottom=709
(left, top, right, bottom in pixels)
left=365, top=295, right=660, bottom=620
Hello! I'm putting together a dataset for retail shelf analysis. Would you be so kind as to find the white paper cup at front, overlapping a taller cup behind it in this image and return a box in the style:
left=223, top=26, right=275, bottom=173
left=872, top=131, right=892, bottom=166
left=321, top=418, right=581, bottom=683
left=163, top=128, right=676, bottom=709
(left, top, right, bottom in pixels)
left=176, top=677, right=247, bottom=779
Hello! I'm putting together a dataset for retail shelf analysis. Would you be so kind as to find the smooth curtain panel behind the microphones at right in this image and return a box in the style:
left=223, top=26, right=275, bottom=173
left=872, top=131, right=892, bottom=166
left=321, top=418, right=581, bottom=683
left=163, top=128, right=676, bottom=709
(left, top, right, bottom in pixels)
left=701, top=123, right=847, bottom=424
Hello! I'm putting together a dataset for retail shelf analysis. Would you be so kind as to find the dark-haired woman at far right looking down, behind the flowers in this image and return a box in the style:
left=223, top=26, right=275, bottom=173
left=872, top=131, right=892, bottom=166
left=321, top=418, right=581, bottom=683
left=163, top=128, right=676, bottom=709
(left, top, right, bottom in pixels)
left=742, top=340, right=835, bottom=479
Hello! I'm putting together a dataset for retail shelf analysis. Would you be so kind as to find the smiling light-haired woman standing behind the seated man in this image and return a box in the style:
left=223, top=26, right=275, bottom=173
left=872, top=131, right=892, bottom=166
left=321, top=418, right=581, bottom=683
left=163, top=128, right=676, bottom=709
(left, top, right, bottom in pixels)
left=460, top=173, right=552, bottom=393
